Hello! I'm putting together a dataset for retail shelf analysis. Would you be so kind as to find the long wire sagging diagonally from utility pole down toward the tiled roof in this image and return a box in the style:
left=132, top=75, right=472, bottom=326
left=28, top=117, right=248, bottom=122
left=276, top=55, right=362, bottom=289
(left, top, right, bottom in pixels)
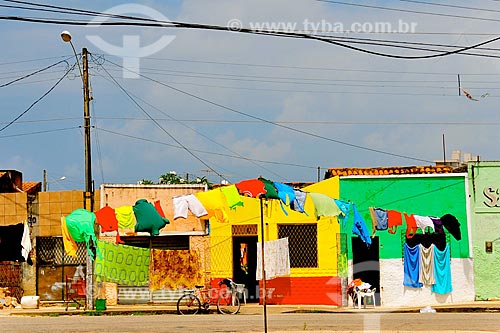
left=106, top=60, right=433, bottom=163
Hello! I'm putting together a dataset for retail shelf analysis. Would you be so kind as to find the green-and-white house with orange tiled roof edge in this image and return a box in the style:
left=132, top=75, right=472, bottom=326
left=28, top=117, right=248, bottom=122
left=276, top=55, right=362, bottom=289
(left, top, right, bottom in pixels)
left=327, top=166, right=474, bottom=306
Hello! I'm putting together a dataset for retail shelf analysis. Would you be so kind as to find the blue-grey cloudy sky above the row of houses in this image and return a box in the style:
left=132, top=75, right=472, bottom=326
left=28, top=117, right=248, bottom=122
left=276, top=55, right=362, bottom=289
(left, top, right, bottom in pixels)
left=0, top=0, right=500, bottom=190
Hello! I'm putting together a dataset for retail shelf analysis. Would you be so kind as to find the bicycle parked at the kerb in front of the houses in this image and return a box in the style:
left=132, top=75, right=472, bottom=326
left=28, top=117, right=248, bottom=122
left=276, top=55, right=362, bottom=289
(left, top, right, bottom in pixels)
left=177, top=279, right=241, bottom=315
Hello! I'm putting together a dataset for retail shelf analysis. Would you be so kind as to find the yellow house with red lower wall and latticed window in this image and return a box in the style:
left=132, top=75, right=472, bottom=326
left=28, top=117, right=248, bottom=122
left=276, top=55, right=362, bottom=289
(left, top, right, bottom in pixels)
left=210, top=178, right=342, bottom=305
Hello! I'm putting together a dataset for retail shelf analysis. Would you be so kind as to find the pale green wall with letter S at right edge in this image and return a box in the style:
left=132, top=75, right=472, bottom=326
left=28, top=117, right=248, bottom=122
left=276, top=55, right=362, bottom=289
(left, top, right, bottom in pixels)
left=468, top=162, right=500, bottom=300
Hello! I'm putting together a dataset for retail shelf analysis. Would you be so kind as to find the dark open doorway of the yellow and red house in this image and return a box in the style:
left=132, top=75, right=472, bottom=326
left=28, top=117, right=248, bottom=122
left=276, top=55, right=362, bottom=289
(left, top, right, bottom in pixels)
left=233, top=236, right=259, bottom=302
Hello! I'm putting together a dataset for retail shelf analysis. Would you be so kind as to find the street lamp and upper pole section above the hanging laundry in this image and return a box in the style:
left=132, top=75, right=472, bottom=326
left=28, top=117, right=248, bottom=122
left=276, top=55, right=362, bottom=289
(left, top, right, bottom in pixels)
left=61, top=30, right=94, bottom=212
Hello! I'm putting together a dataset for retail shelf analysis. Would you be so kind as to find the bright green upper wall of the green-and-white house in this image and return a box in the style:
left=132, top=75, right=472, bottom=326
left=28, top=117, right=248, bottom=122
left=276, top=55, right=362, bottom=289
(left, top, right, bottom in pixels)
left=340, top=174, right=470, bottom=259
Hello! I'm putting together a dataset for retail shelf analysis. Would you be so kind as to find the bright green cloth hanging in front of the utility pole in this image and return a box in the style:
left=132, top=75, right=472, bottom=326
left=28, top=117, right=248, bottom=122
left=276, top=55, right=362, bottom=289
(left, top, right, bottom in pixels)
left=66, top=208, right=97, bottom=260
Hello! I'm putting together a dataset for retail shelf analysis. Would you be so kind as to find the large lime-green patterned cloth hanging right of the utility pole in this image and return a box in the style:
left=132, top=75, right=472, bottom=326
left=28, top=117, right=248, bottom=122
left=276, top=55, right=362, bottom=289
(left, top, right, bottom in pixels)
left=95, top=240, right=151, bottom=286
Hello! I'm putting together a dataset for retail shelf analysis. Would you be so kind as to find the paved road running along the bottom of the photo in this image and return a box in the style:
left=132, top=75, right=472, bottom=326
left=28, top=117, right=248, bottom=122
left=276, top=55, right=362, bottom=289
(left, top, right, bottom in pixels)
left=0, top=313, right=500, bottom=333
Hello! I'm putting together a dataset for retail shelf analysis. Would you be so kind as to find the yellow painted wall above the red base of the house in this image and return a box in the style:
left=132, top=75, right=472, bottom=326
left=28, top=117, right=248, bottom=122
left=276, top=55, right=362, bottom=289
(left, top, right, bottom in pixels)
left=210, top=177, right=340, bottom=278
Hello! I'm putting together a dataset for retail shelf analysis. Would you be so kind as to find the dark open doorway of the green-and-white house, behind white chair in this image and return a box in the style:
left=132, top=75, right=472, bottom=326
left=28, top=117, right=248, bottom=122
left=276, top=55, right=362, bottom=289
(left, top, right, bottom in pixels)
left=352, top=236, right=381, bottom=305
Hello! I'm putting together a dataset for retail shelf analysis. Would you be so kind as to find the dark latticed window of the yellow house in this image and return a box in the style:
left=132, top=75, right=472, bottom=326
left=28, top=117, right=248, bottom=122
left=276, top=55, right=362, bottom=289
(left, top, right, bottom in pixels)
left=278, top=224, right=318, bottom=268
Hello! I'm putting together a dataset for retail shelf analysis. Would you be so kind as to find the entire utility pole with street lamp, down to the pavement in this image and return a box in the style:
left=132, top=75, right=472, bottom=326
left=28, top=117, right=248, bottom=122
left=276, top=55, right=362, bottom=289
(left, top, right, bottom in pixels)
left=61, top=31, right=96, bottom=310
